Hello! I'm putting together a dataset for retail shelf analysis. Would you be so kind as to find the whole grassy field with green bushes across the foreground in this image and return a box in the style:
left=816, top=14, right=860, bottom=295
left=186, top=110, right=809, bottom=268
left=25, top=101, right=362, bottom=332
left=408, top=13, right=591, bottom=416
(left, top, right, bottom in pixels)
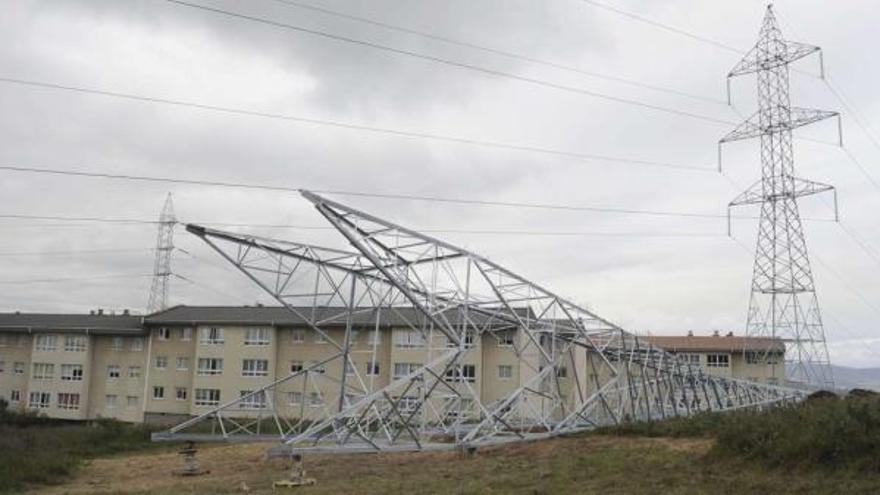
left=6, top=397, right=880, bottom=495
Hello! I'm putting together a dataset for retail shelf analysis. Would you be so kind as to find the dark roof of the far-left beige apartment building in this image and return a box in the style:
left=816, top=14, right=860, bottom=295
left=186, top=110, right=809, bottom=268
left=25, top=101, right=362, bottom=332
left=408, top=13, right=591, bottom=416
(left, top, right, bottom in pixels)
left=0, top=313, right=144, bottom=335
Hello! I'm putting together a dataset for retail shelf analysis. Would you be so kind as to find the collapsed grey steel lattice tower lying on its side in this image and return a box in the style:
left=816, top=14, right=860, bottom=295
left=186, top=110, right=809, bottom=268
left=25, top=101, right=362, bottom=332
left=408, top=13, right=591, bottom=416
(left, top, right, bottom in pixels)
left=153, top=192, right=805, bottom=452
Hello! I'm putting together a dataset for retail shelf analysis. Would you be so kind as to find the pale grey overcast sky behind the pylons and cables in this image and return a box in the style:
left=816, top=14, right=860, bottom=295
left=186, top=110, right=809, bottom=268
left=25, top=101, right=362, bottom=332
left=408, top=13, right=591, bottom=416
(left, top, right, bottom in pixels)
left=0, top=0, right=880, bottom=366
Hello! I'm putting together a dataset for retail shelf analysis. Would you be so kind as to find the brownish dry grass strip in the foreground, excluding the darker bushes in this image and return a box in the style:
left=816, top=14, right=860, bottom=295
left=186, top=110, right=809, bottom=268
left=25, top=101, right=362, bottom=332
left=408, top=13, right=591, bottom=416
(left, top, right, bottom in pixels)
left=25, top=435, right=880, bottom=495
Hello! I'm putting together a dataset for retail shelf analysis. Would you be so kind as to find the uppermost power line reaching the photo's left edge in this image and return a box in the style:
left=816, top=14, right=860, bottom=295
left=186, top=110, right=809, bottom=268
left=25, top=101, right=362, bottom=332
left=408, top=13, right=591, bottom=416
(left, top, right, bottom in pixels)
left=0, top=77, right=728, bottom=174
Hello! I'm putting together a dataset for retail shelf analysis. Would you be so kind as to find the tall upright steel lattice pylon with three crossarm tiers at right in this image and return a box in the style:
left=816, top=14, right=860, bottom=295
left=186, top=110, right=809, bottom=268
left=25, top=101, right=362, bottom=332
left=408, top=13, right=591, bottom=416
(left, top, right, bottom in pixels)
left=721, top=5, right=840, bottom=387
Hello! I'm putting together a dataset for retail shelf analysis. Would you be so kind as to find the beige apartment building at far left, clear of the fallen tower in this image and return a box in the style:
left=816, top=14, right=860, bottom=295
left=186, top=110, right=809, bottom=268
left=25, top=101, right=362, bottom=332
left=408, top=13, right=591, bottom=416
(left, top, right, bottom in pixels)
left=0, top=312, right=146, bottom=422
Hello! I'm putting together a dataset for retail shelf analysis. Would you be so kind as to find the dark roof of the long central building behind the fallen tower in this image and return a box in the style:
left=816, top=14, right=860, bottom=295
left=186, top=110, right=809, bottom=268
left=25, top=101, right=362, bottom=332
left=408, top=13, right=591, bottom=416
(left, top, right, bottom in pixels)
left=144, top=305, right=530, bottom=326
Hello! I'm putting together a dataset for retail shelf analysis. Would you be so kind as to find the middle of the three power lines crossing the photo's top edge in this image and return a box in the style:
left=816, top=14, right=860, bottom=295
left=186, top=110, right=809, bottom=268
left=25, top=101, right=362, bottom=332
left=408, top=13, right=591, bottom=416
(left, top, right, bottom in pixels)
left=272, top=0, right=727, bottom=105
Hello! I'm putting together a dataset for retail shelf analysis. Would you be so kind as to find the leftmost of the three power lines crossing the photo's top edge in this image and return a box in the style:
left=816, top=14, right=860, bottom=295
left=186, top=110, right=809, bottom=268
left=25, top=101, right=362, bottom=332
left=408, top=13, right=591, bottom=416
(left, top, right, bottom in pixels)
left=165, top=0, right=735, bottom=125
